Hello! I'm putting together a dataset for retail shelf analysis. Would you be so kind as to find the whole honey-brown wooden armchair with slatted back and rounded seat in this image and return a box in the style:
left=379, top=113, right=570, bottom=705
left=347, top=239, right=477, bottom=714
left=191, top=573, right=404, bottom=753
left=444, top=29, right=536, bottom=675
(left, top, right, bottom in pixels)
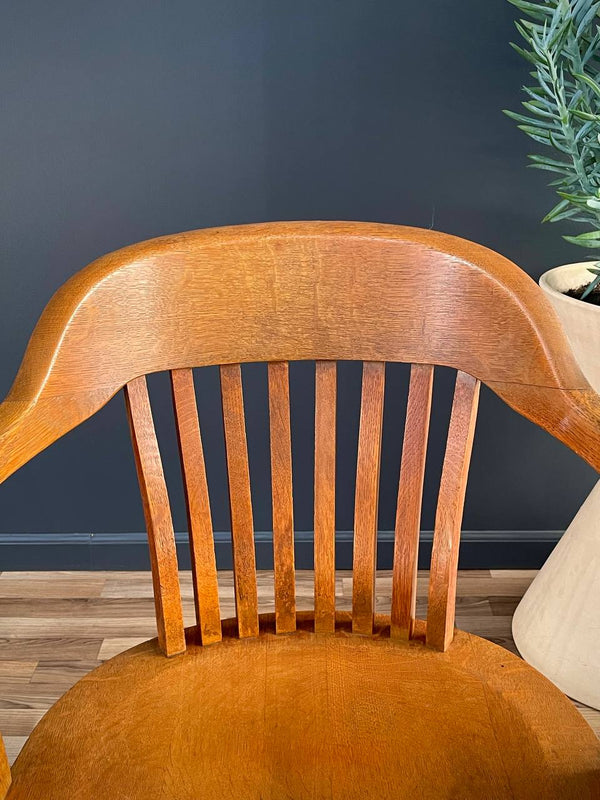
left=0, top=222, right=600, bottom=800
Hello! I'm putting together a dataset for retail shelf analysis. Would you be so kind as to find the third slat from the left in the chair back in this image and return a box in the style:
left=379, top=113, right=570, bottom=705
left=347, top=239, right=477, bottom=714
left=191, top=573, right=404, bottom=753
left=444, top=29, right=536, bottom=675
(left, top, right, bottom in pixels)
left=220, top=364, right=258, bottom=637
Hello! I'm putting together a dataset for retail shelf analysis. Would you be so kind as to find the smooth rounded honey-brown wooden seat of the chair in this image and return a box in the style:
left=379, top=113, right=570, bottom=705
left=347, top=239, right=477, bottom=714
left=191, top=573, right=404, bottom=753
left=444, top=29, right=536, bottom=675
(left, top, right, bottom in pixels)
left=8, top=614, right=600, bottom=800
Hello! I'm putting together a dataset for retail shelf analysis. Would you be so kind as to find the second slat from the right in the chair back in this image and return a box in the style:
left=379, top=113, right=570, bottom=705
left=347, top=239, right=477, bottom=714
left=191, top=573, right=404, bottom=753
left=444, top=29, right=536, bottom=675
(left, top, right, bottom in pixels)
left=391, top=364, right=433, bottom=639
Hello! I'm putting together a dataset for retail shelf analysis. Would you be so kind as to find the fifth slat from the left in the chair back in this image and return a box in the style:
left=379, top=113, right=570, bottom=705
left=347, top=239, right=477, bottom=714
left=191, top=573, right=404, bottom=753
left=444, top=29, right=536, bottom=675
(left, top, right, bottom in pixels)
left=314, top=361, right=337, bottom=633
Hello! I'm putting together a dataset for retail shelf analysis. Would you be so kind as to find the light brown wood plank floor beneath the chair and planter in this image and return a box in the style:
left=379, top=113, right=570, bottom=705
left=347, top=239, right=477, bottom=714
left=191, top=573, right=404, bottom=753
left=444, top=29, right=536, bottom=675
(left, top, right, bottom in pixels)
left=0, top=570, right=600, bottom=761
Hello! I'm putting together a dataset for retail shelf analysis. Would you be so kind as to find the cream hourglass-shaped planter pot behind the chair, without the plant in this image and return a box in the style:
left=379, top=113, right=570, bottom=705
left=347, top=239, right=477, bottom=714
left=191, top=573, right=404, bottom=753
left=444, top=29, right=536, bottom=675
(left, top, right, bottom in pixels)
left=513, top=262, right=600, bottom=709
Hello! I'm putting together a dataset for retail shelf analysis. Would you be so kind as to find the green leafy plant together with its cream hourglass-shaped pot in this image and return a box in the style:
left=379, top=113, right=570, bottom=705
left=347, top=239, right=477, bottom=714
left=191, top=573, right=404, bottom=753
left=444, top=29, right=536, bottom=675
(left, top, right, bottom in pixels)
left=505, top=0, right=600, bottom=708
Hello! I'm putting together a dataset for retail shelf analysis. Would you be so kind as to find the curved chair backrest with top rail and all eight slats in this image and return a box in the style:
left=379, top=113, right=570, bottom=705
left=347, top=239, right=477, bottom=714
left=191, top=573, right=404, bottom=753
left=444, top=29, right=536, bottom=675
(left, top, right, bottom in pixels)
left=0, top=222, right=600, bottom=655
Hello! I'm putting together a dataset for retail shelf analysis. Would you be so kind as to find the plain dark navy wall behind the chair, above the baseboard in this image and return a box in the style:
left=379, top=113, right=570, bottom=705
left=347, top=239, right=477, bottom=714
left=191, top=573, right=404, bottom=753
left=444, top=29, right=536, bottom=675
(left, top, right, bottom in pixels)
left=0, top=0, right=594, bottom=548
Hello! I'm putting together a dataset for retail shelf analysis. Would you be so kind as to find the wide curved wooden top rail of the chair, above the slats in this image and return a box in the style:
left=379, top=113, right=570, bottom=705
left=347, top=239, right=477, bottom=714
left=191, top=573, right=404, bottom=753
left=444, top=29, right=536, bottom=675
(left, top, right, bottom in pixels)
left=0, top=222, right=600, bottom=481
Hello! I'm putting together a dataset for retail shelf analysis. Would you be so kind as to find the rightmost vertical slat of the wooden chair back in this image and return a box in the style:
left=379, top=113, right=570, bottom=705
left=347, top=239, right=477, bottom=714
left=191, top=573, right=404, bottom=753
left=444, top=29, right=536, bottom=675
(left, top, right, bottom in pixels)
left=427, top=372, right=480, bottom=650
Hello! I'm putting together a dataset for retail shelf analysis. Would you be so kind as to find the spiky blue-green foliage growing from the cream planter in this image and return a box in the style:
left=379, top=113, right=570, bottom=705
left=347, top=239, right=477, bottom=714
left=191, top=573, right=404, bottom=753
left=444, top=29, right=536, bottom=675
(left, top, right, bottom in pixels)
left=504, top=0, right=600, bottom=272
